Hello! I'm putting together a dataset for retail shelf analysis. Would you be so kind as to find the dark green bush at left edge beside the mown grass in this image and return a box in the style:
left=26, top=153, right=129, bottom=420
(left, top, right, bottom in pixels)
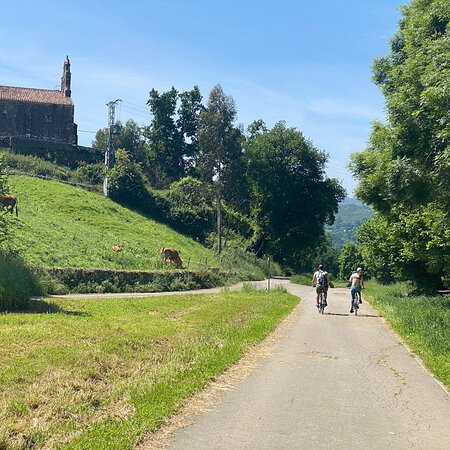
left=0, top=253, right=43, bottom=311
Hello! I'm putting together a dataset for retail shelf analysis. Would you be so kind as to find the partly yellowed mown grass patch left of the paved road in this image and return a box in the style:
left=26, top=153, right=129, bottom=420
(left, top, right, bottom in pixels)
left=0, top=289, right=298, bottom=450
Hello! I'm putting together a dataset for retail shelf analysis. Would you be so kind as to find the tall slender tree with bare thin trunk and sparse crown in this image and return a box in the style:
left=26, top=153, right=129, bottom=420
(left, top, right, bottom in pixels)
left=195, top=85, right=242, bottom=254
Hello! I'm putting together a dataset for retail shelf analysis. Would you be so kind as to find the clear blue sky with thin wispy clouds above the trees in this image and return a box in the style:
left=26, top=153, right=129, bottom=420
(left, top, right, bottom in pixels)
left=0, top=0, right=404, bottom=194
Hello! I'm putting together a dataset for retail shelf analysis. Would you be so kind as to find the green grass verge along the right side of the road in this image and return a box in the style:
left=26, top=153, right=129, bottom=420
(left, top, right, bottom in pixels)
left=365, top=281, right=450, bottom=387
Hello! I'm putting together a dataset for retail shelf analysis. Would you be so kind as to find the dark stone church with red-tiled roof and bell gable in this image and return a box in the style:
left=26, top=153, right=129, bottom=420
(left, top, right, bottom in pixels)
left=0, top=57, right=78, bottom=145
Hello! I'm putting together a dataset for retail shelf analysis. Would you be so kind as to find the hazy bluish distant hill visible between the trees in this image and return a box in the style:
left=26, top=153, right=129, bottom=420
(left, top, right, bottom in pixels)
left=326, top=197, right=373, bottom=248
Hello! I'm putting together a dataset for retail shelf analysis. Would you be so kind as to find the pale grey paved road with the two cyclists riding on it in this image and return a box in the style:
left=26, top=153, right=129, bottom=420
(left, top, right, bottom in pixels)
left=163, top=282, right=450, bottom=450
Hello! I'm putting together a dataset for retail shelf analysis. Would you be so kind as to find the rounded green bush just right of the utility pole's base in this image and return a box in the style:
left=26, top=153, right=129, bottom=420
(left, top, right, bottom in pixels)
left=108, top=149, right=148, bottom=205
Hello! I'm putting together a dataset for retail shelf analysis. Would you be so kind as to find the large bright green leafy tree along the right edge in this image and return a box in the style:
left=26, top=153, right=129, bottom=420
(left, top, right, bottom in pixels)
left=351, top=0, right=450, bottom=288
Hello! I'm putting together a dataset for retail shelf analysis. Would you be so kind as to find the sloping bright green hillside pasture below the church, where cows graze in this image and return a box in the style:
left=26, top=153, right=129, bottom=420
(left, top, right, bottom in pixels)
left=10, top=176, right=217, bottom=270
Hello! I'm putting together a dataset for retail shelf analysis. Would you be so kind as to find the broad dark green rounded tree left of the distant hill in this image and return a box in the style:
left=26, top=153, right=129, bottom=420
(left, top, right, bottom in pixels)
left=245, top=122, right=345, bottom=270
